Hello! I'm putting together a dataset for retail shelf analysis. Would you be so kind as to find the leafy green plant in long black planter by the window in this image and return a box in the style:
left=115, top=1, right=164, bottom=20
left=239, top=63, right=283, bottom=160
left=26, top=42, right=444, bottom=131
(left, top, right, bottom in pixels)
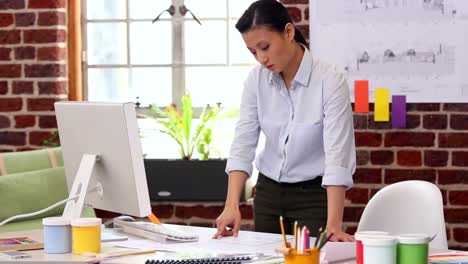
left=140, top=94, right=238, bottom=201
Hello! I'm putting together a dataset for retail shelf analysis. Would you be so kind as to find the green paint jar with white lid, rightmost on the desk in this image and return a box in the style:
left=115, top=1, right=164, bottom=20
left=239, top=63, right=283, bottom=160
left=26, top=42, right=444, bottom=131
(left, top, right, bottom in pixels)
left=397, top=234, right=429, bottom=264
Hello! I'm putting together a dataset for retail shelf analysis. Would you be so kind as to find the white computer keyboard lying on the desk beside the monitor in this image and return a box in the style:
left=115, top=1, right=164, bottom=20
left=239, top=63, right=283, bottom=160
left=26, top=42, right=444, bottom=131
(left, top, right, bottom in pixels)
left=114, top=219, right=198, bottom=242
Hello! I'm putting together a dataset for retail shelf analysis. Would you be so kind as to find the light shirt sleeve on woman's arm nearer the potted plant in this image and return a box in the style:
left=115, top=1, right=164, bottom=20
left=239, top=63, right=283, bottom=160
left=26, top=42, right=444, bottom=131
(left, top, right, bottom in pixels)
left=226, top=68, right=260, bottom=177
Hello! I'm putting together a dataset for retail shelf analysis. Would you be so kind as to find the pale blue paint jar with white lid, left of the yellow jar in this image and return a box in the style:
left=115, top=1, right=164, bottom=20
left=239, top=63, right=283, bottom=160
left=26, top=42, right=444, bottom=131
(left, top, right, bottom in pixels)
left=42, top=217, right=72, bottom=254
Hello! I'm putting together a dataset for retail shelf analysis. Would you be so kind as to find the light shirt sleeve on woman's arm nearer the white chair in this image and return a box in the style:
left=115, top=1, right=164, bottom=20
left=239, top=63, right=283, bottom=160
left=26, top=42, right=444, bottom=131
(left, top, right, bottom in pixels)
left=322, top=74, right=356, bottom=189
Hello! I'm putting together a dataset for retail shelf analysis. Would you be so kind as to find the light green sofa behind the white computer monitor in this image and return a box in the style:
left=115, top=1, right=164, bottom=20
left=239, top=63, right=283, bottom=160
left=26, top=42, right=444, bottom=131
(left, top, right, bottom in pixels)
left=0, top=148, right=95, bottom=233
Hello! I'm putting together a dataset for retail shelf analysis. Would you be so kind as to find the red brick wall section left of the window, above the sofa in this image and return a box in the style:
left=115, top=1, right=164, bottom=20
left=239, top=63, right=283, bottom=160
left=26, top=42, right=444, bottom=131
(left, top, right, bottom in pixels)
left=0, top=0, right=68, bottom=152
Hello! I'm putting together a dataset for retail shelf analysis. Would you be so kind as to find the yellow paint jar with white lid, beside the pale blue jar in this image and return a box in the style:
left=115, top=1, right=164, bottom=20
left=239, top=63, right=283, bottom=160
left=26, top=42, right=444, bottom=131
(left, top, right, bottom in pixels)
left=71, top=218, right=102, bottom=254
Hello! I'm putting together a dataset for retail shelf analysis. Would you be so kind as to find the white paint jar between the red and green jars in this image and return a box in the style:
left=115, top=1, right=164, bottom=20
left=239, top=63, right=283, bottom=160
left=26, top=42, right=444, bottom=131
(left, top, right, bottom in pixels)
left=362, top=236, right=397, bottom=264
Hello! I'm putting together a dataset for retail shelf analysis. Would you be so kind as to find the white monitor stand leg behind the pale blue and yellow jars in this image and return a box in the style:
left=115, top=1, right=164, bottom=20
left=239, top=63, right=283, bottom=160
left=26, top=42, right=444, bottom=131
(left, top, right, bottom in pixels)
left=62, top=154, right=103, bottom=219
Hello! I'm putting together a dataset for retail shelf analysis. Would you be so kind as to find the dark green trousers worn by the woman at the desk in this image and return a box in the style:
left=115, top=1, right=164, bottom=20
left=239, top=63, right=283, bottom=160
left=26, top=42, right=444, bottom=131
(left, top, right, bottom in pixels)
left=254, top=173, right=327, bottom=236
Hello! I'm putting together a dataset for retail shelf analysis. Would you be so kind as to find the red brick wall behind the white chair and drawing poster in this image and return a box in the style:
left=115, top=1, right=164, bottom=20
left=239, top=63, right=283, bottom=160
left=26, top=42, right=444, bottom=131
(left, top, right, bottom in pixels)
left=282, top=0, right=468, bottom=250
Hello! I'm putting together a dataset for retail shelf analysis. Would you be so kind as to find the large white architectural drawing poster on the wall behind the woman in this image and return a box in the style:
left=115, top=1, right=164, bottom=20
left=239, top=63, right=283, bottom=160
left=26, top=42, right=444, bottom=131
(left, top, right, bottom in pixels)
left=310, top=0, right=468, bottom=102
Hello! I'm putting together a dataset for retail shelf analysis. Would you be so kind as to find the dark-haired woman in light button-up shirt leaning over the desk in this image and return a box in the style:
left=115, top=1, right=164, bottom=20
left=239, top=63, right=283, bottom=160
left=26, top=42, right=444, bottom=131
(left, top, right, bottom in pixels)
left=213, top=0, right=356, bottom=241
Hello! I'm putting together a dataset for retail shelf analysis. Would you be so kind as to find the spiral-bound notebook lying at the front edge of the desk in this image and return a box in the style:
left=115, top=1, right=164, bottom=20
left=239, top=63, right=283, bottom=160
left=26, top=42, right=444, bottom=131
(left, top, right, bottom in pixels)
left=145, top=256, right=252, bottom=264
